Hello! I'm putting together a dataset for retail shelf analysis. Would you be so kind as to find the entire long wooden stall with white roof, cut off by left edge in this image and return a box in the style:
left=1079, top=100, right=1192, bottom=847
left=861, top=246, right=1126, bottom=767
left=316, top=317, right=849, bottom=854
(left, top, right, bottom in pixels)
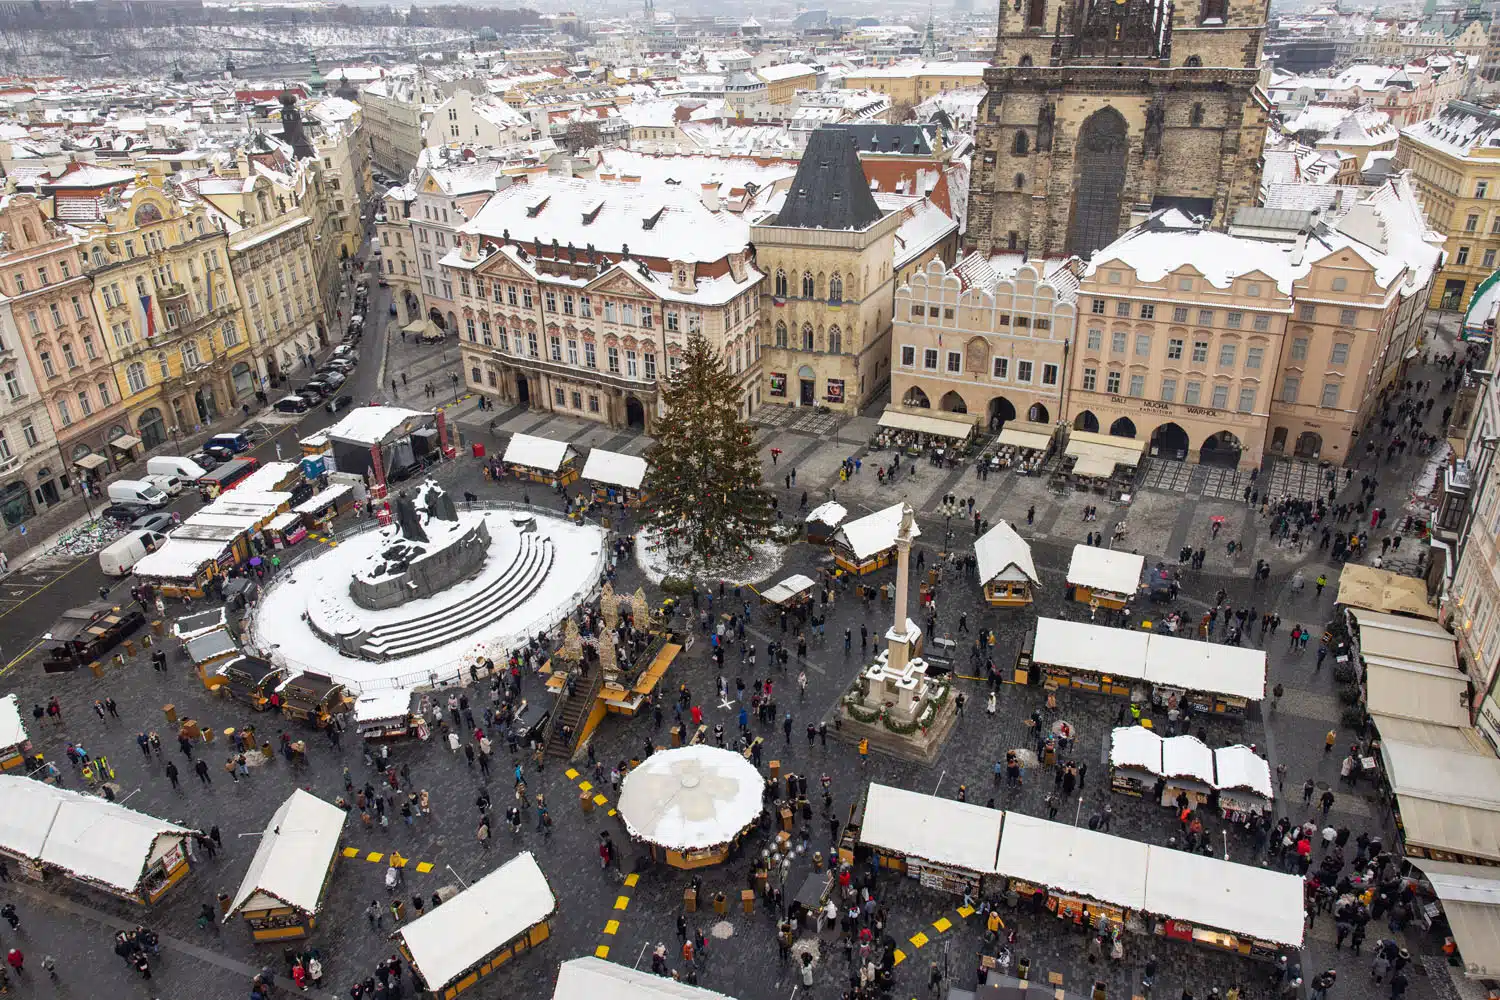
left=0, top=775, right=197, bottom=904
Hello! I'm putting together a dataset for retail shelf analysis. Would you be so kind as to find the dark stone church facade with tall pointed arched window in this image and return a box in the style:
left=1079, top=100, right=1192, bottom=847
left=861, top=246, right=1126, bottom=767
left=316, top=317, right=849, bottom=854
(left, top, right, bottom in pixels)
left=969, top=0, right=1269, bottom=258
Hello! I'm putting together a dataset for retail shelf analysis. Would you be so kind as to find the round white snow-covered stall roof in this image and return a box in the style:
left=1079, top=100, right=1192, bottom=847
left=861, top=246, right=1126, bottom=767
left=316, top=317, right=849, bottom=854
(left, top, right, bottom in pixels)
left=617, top=744, right=765, bottom=850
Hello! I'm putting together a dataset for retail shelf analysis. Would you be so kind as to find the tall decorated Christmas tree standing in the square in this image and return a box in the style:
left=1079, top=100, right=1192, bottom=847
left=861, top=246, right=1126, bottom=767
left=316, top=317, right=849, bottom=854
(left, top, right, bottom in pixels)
left=645, top=336, right=776, bottom=567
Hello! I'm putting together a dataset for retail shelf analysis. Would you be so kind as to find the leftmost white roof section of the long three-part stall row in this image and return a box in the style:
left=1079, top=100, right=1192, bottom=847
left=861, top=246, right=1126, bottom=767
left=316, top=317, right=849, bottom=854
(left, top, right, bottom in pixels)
left=860, top=781, right=1005, bottom=874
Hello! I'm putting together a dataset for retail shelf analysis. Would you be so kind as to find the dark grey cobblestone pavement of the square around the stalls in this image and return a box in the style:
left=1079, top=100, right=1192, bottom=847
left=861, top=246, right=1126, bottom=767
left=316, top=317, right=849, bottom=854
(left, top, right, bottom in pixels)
left=0, top=314, right=1451, bottom=1000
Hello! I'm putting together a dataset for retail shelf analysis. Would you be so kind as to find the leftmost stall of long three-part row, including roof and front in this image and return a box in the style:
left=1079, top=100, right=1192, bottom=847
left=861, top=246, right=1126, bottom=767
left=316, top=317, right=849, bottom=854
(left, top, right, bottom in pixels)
left=860, top=781, right=1005, bottom=897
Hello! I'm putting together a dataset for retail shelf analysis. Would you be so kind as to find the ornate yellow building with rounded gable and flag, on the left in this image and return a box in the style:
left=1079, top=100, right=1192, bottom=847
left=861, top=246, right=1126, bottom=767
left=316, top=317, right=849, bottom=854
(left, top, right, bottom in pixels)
left=73, top=174, right=257, bottom=448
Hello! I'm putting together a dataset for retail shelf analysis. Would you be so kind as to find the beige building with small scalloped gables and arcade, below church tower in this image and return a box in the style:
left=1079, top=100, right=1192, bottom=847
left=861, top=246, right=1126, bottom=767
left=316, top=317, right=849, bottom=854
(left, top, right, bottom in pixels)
left=891, top=253, right=1079, bottom=433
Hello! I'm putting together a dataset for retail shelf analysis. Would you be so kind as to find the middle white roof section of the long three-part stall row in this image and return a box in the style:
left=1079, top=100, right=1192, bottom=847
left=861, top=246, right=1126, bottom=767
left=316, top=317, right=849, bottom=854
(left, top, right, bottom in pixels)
left=995, top=811, right=1148, bottom=910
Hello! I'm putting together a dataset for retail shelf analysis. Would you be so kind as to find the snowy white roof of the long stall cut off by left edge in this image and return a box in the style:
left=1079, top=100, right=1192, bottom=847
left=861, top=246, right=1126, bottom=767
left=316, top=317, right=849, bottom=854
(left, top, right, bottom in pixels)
left=0, top=775, right=194, bottom=892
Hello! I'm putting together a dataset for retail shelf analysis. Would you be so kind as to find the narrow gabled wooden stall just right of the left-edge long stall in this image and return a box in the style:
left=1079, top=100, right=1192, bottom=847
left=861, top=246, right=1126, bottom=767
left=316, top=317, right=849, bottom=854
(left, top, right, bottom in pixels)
left=224, top=789, right=348, bottom=943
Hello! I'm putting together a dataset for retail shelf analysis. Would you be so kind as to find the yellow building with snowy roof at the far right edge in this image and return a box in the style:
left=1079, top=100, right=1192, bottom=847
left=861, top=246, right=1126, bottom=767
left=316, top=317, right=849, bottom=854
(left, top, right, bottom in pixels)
left=1397, top=100, right=1500, bottom=309
